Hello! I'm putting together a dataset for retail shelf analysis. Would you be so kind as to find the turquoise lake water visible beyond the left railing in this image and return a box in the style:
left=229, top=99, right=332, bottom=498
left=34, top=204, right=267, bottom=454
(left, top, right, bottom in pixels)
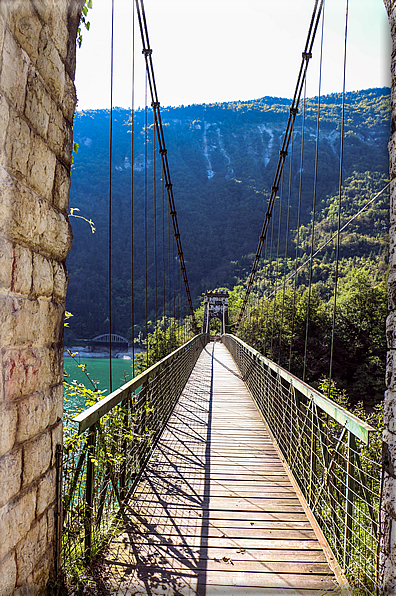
left=65, top=356, right=132, bottom=408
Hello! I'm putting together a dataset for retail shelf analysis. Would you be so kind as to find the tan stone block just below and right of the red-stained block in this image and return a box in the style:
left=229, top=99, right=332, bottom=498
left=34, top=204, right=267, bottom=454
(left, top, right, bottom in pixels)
left=17, top=392, right=52, bottom=443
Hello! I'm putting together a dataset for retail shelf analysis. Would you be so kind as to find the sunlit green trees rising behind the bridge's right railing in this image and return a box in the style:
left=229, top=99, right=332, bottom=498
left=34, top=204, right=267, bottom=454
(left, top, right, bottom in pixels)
left=240, top=261, right=387, bottom=406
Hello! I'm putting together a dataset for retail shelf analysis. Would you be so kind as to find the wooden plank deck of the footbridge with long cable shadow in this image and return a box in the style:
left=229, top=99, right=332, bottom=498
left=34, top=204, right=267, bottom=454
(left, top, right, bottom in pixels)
left=107, top=343, right=341, bottom=596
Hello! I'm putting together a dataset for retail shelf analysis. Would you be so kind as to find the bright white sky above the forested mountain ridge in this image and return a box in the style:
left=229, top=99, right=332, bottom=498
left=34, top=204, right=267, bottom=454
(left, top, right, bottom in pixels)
left=76, top=0, right=391, bottom=110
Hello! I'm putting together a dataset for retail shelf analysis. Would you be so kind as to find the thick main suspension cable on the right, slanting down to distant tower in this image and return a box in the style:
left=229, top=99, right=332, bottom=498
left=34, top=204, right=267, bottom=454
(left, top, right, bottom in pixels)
left=236, top=0, right=324, bottom=328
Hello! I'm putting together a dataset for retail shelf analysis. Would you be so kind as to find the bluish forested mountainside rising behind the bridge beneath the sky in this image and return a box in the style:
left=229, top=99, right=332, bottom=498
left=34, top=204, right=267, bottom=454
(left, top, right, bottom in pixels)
left=66, top=89, right=390, bottom=340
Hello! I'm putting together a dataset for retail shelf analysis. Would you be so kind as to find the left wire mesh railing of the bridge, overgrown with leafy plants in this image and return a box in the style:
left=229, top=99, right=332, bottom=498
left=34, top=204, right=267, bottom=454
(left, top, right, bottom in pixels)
left=58, top=334, right=208, bottom=585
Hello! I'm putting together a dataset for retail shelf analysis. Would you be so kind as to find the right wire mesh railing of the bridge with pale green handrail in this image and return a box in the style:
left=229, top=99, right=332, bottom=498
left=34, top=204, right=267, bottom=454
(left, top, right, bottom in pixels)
left=222, top=334, right=381, bottom=595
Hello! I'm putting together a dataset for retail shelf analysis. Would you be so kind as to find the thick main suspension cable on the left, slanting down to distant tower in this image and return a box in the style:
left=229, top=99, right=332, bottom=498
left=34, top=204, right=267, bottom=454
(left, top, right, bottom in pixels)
left=136, top=0, right=198, bottom=333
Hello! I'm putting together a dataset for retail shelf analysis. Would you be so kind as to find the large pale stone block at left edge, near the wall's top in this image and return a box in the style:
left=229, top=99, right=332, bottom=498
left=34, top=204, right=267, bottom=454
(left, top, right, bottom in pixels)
left=0, top=29, right=28, bottom=113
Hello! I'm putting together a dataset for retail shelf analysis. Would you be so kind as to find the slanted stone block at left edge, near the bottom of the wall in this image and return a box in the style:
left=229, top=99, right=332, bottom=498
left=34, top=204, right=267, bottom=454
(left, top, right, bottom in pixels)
left=0, top=490, right=36, bottom=560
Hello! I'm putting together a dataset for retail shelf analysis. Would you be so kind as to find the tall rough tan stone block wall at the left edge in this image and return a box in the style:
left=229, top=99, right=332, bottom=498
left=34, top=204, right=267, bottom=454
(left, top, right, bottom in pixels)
left=0, top=0, right=83, bottom=596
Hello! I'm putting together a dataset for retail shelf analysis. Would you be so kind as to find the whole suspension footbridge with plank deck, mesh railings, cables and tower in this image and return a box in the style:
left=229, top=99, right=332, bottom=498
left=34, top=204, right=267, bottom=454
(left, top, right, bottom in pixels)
left=57, top=0, right=388, bottom=596
